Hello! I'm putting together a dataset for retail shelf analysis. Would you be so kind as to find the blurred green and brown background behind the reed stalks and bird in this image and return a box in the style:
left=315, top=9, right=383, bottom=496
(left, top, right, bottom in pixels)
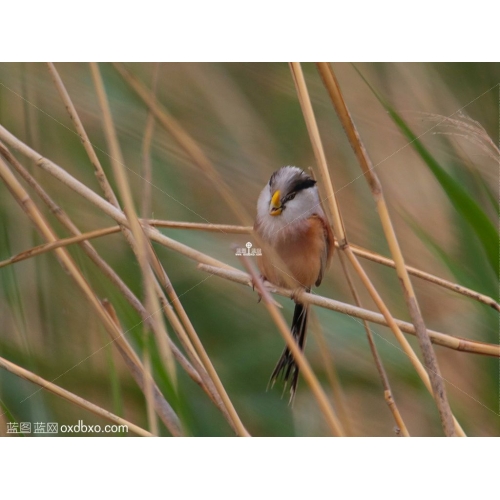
left=0, top=63, right=500, bottom=436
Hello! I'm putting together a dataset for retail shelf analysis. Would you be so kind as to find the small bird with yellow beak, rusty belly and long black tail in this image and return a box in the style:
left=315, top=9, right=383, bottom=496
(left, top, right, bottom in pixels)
left=254, top=166, right=334, bottom=402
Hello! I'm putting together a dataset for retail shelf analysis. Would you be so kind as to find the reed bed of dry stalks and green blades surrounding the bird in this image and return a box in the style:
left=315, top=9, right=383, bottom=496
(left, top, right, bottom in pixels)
left=0, top=63, right=500, bottom=436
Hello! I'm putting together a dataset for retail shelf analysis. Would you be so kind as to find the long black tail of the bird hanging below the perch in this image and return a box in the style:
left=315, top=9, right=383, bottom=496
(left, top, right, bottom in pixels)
left=269, top=303, right=308, bottom=403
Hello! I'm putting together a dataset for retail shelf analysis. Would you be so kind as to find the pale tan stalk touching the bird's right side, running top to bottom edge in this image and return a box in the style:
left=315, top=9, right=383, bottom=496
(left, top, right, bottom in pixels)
left=290, top=63, right=463, bottom=435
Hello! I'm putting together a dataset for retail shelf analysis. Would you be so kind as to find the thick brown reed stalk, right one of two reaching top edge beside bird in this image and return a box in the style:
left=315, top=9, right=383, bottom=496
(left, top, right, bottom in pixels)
left=317, top=63, right=458, bottom=436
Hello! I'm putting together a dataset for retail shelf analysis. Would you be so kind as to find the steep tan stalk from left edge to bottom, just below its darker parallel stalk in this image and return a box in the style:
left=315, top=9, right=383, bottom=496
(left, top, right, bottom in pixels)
left=0, top=154, right=181, bottom=436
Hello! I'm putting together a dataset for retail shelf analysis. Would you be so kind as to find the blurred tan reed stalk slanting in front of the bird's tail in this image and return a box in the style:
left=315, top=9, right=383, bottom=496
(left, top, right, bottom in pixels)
left=240, top=258, right=344, bottom=436
